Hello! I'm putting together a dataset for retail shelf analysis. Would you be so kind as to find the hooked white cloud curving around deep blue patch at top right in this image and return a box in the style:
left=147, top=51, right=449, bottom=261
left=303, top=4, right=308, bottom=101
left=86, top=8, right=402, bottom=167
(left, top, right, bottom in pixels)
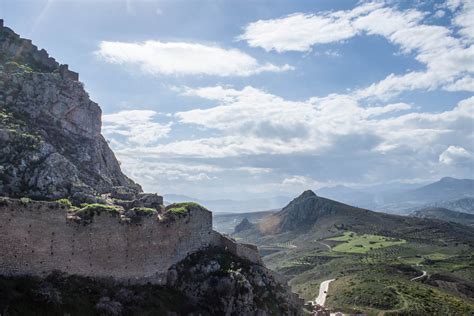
left=238, top=1, right=474, bottom=99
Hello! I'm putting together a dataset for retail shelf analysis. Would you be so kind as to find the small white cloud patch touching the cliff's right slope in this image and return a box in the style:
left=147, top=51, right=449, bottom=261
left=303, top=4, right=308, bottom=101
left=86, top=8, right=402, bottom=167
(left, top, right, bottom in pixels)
left=102, top=110, right=172, bottom=145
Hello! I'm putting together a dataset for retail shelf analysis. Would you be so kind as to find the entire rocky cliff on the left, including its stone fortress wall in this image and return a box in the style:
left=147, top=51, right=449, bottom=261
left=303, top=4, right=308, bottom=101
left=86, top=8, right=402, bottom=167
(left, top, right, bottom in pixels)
left=0, top=20, right=302, bottom=315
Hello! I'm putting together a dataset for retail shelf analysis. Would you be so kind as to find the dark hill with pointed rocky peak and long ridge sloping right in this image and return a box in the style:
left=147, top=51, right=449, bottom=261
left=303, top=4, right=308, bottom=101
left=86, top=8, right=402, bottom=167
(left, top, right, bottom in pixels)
left=232, top=190, right=474, bottom=244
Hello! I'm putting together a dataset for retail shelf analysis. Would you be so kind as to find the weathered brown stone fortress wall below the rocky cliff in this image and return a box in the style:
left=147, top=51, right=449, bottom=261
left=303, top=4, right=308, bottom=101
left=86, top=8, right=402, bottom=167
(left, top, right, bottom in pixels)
left=0, top=200, right=214, bottom=283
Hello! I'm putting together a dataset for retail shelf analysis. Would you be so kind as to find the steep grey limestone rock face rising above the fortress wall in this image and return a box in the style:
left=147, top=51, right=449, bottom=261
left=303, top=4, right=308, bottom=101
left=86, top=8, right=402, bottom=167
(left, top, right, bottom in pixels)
left=0, top=21, right=141, bottom=201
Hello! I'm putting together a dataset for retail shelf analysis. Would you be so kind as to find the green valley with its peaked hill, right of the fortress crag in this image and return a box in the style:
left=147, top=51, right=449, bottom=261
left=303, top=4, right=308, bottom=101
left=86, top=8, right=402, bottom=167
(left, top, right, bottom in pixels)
left=220, top=191, right=474, bottom=315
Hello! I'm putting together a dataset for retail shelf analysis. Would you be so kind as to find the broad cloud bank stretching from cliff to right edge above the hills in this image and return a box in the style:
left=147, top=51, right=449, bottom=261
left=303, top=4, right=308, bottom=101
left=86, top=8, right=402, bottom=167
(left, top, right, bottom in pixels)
left=105, top=86, right=474, bottom=196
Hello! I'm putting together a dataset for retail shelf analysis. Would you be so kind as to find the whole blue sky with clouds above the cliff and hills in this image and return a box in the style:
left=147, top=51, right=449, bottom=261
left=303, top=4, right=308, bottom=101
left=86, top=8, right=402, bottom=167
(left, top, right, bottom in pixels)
left=0, top=0, right=474, bottom=199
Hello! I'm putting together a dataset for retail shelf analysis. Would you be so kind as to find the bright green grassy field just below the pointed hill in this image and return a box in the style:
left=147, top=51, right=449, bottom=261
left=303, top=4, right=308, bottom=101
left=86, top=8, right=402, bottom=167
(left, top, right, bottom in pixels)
left=327, top=232, right=406, bottom=254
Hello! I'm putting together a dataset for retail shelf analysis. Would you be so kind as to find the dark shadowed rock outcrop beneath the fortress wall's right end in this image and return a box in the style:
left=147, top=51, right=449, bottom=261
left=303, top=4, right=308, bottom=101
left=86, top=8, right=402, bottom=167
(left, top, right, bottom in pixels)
left=167, top=248, right=302, bottom=316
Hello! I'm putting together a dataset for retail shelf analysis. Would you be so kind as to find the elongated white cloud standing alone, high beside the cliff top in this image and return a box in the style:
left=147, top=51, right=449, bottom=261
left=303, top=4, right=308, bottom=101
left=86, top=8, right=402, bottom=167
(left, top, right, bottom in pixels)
left=97, top=41, right=293, bottom=77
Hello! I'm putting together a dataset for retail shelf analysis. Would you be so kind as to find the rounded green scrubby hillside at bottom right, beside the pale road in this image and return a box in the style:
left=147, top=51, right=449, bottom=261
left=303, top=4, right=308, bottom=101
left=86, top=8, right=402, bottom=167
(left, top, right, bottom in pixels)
left=327, top=267, right=474, bottom=315
